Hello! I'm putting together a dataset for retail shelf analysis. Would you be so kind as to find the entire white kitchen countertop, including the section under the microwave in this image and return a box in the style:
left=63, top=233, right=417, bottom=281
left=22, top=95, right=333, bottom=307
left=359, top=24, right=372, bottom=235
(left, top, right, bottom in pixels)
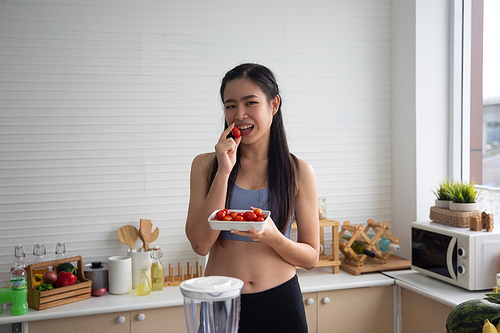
left=0, top=267, right=491, bottom=325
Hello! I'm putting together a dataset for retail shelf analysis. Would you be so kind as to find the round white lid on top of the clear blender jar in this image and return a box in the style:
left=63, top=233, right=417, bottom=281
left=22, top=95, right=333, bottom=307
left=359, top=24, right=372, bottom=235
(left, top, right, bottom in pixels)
left=180, top=276, right=243, bottom=301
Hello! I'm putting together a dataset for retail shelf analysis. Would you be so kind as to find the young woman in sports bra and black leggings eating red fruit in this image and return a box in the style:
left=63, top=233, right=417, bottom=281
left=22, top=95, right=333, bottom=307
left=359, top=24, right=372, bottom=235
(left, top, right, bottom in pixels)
left=186, top=64, right=319, bottom=333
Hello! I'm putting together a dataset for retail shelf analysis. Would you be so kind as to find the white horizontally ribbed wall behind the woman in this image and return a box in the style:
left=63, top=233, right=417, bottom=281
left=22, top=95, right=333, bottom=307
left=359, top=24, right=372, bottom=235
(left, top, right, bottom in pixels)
left=0, top=0, right=392, bottom=276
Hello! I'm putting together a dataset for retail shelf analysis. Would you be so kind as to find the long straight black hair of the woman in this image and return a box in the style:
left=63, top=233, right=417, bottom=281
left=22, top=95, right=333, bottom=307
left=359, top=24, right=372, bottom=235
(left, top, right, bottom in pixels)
left=207, top=63, right=298, bottom=233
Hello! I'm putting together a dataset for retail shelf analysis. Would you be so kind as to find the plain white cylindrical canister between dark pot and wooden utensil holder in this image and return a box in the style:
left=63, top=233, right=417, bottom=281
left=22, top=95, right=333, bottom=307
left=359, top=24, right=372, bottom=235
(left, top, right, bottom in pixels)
left=108, top=256, right=132, bottom=295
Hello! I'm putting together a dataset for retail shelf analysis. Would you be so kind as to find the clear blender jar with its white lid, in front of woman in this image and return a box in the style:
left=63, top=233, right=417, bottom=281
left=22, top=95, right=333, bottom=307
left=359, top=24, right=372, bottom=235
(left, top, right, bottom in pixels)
left=180, top=276, right=243, bottom=333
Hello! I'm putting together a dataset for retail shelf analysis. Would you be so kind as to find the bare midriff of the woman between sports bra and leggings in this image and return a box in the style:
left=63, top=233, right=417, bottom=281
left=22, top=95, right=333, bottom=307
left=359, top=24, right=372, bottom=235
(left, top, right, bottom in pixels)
left=205, top=240, right=296, bottom=294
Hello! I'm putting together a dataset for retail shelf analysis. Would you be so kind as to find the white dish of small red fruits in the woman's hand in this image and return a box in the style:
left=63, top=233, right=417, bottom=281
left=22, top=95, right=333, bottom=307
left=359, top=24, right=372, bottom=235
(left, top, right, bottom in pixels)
left=208, top=208, right=271, bottom=231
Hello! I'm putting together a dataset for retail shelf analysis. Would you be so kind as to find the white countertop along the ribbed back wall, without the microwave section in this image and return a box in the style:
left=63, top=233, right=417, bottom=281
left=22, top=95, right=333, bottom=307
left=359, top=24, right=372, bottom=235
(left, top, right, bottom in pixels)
left=0, top=267, right=394, bottom=325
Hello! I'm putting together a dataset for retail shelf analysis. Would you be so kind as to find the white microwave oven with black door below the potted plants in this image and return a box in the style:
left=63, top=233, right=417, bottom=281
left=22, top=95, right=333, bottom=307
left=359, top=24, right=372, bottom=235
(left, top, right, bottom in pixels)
left=411, top=222, right=500, bottom=290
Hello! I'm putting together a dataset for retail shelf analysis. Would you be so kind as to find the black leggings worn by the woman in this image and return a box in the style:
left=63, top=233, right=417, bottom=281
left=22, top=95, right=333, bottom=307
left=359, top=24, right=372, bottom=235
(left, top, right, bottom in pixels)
left=238, top=275, right=307, bottom=333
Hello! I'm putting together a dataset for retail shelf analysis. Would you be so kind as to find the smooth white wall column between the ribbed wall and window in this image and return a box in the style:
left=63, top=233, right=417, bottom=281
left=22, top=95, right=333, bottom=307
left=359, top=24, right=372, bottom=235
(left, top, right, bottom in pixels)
left=391, top=0, right=449, bottom=258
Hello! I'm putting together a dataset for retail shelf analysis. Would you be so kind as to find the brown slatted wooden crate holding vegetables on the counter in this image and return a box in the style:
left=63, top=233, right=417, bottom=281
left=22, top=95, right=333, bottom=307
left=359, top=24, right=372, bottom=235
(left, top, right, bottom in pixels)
left=27, top=256, right=92, bottom=310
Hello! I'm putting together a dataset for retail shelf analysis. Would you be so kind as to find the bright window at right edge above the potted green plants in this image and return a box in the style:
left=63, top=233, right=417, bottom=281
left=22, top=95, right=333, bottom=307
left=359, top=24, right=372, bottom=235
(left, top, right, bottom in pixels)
left=468, top=0, right=500, bottom=220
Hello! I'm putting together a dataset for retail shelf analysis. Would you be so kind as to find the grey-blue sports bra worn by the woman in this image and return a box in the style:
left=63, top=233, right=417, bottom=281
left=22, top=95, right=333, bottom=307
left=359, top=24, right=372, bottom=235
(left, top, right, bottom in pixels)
left=221, top=184, right=292, bottom=242
